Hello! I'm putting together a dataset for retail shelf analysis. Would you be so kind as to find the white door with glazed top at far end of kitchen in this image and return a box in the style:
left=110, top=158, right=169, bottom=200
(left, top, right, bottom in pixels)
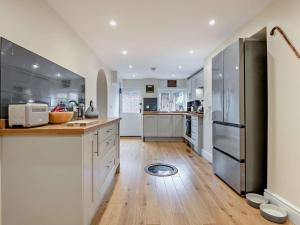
left=120, top=88, right=142, bottom=137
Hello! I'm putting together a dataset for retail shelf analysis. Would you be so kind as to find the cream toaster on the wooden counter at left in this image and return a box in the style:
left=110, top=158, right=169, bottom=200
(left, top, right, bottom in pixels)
left=8, top=103, right=49, bottom=127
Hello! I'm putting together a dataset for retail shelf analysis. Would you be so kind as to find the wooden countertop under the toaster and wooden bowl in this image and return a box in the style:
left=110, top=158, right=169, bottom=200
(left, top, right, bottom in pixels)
left=0, top=117, right=121, bottom=136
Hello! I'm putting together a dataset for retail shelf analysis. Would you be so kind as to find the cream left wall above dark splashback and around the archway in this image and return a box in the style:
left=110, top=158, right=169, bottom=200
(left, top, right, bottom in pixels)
left=0, top=0, right=116, bottom=116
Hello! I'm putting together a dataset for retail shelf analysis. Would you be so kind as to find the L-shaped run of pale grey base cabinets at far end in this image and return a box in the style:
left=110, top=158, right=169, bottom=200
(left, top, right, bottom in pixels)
left=143, top=111, right=203, bottom=154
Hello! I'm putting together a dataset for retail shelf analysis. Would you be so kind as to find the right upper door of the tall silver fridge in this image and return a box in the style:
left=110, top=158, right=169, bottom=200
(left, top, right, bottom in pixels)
left=224, top=39, right=244, bottom=124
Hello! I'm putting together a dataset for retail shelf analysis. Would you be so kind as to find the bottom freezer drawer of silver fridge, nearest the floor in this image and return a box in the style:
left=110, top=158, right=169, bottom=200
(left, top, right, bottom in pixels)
left=213, top=149, right=245, bottom=194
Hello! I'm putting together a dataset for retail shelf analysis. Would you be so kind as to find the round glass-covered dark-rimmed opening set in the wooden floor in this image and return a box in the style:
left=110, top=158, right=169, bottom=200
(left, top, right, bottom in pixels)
left=145, top=163, right=178, bottom=177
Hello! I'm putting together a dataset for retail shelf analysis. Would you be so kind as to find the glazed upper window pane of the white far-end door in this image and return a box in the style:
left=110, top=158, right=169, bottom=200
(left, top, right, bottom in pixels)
left=122, top=89, right=141, bottom=113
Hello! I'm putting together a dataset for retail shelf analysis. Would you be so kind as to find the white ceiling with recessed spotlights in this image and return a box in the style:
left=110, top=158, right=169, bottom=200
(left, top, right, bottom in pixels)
left=46, top=0, right=272, bottom=78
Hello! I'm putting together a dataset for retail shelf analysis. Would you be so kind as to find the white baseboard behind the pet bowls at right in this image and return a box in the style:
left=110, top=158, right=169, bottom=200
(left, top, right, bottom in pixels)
left=264, top=189, right=300, bottom=225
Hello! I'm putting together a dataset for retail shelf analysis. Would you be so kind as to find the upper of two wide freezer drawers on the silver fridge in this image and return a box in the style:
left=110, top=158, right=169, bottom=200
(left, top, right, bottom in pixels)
left=213, top=123, right=245, bottom=160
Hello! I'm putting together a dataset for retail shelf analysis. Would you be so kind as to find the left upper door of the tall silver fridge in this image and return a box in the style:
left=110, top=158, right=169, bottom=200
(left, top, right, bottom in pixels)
left=212, top=52, right=223, bottom=122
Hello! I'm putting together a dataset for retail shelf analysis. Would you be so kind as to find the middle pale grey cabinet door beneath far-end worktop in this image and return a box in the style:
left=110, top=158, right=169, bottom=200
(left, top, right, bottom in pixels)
left=157, top=115, right=173, bottom=137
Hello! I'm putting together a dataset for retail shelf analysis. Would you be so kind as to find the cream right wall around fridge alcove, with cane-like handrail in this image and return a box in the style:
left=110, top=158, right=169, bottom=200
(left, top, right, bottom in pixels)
left=204, top=0, right=300, bottom=208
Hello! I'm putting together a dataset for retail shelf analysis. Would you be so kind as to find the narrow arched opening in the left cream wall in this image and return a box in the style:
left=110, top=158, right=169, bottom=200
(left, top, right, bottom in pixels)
left=97, top=70, right=107, bottom=117
